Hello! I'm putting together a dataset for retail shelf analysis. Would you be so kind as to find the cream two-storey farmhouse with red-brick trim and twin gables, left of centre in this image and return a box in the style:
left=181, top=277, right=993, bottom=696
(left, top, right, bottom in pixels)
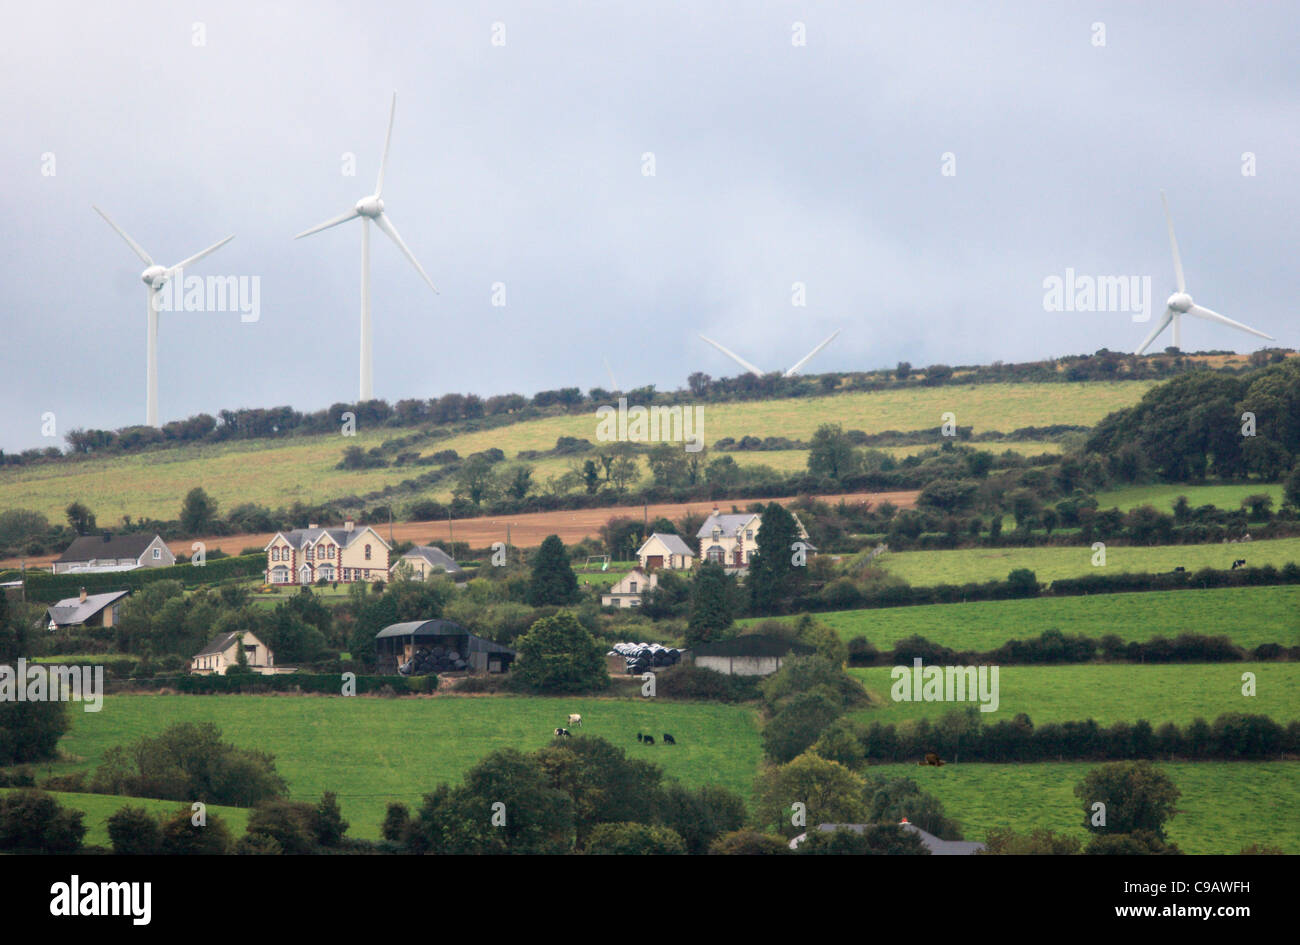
left=267, top=519, right=389, bottom=584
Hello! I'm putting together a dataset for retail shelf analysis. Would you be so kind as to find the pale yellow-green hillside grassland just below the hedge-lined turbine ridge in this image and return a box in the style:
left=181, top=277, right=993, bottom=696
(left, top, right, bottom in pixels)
left=0, top=381, right=1152, bottom=525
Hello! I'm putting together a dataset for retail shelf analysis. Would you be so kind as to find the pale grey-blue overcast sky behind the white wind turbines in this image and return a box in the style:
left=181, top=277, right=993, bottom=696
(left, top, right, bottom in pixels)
left=0, top=0, right=1300, bottom=450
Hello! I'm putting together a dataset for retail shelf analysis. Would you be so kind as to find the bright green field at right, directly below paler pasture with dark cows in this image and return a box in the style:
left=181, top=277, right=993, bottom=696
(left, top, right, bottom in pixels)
left=741, top=585, right=1300, bottom=650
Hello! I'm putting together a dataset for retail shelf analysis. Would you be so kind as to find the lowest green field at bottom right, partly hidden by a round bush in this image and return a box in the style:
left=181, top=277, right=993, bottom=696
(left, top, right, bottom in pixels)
left=863, top=762, right=1300, bottom=854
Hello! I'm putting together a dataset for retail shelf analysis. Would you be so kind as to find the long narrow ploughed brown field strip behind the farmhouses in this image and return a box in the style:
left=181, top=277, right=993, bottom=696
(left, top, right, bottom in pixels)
left=0, top=490, right=918, bottom=568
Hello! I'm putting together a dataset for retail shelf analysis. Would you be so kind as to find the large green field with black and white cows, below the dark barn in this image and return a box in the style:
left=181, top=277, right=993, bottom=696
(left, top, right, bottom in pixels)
left=48, top=695, right=761, bottom=838
